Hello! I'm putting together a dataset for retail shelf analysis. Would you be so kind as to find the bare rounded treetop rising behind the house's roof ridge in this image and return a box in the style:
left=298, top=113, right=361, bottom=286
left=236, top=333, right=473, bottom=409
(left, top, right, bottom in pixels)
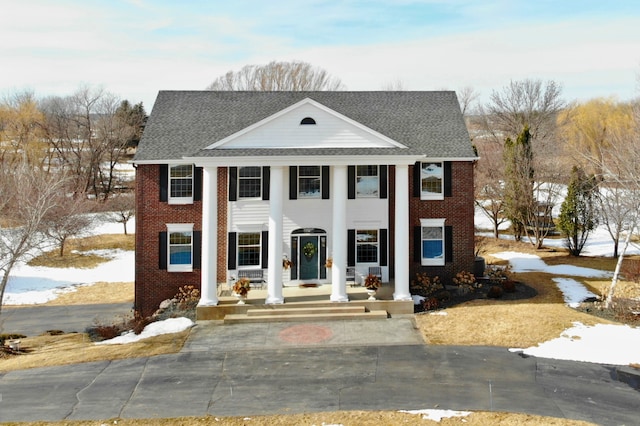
left=207, top=61, right=344, bottom=91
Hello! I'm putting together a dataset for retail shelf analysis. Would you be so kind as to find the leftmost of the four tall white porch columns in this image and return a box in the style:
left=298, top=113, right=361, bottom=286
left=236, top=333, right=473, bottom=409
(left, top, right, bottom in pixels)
left=198, top=167, right=218, bottom=306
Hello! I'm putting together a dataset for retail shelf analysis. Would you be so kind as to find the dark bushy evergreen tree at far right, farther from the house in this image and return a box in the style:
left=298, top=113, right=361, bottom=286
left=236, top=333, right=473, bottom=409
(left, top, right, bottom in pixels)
left=558, top=166, right=597, bottom=256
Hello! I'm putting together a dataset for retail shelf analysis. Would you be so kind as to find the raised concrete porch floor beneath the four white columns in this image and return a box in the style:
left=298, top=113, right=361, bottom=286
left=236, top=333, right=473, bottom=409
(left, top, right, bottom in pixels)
left=197, top=283, right=413, bottom=320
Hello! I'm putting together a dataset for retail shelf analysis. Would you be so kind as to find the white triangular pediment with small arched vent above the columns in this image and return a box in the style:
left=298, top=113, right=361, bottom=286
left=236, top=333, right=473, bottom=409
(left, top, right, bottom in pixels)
left=206, top=98, right=405, bottom=149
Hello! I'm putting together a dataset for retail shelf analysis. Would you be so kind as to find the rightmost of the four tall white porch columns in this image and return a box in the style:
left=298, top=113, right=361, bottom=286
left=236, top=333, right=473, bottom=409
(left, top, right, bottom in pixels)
left=393, top=164, right=411, bottom=300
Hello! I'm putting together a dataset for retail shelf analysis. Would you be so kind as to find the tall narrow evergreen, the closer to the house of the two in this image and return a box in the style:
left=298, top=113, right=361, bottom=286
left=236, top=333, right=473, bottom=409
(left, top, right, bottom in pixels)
left=503, top=126, right=535, bottom=241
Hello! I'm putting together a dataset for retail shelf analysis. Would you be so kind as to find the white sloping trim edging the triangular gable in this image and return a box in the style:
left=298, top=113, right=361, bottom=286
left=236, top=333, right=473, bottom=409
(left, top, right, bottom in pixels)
left=205, top=98, right=407, bottom=149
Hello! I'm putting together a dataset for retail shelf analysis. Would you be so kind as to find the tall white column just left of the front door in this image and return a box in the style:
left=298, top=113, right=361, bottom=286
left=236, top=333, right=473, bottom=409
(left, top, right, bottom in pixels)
left=265, top=166, right=284, bottom=304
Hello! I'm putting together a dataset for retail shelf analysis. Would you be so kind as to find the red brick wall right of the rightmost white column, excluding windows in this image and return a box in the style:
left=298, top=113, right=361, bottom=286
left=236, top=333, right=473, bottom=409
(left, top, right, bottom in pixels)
left=409, top=161, right=475, bottom=282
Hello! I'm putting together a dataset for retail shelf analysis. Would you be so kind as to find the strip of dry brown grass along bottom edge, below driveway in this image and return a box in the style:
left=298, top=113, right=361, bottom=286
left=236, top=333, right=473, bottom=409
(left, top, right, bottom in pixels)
left=3, top=411, right=594, bottom=426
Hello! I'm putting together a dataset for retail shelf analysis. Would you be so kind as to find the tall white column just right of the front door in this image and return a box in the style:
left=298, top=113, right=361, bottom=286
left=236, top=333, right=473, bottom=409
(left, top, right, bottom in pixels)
left=330, top=166, right=349, bottom=302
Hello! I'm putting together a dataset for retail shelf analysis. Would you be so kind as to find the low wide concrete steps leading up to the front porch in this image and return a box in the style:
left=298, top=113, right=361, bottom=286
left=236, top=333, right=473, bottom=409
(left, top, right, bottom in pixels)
left=224, top=310, right=388, bottom=324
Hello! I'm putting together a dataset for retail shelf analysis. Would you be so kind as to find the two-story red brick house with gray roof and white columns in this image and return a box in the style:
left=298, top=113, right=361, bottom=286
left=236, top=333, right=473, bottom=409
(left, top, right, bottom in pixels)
left=134, top=91, right=476, bottom=314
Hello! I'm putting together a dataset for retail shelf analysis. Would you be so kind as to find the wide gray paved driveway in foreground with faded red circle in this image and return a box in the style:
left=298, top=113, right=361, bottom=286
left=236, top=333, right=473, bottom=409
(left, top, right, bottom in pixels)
left=0, top=318, right=640, bottom=425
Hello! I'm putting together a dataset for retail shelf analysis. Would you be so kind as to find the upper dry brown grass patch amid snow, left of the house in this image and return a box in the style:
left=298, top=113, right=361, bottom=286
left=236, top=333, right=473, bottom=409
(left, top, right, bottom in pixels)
left=29, top=234, right=135, bottom=268
